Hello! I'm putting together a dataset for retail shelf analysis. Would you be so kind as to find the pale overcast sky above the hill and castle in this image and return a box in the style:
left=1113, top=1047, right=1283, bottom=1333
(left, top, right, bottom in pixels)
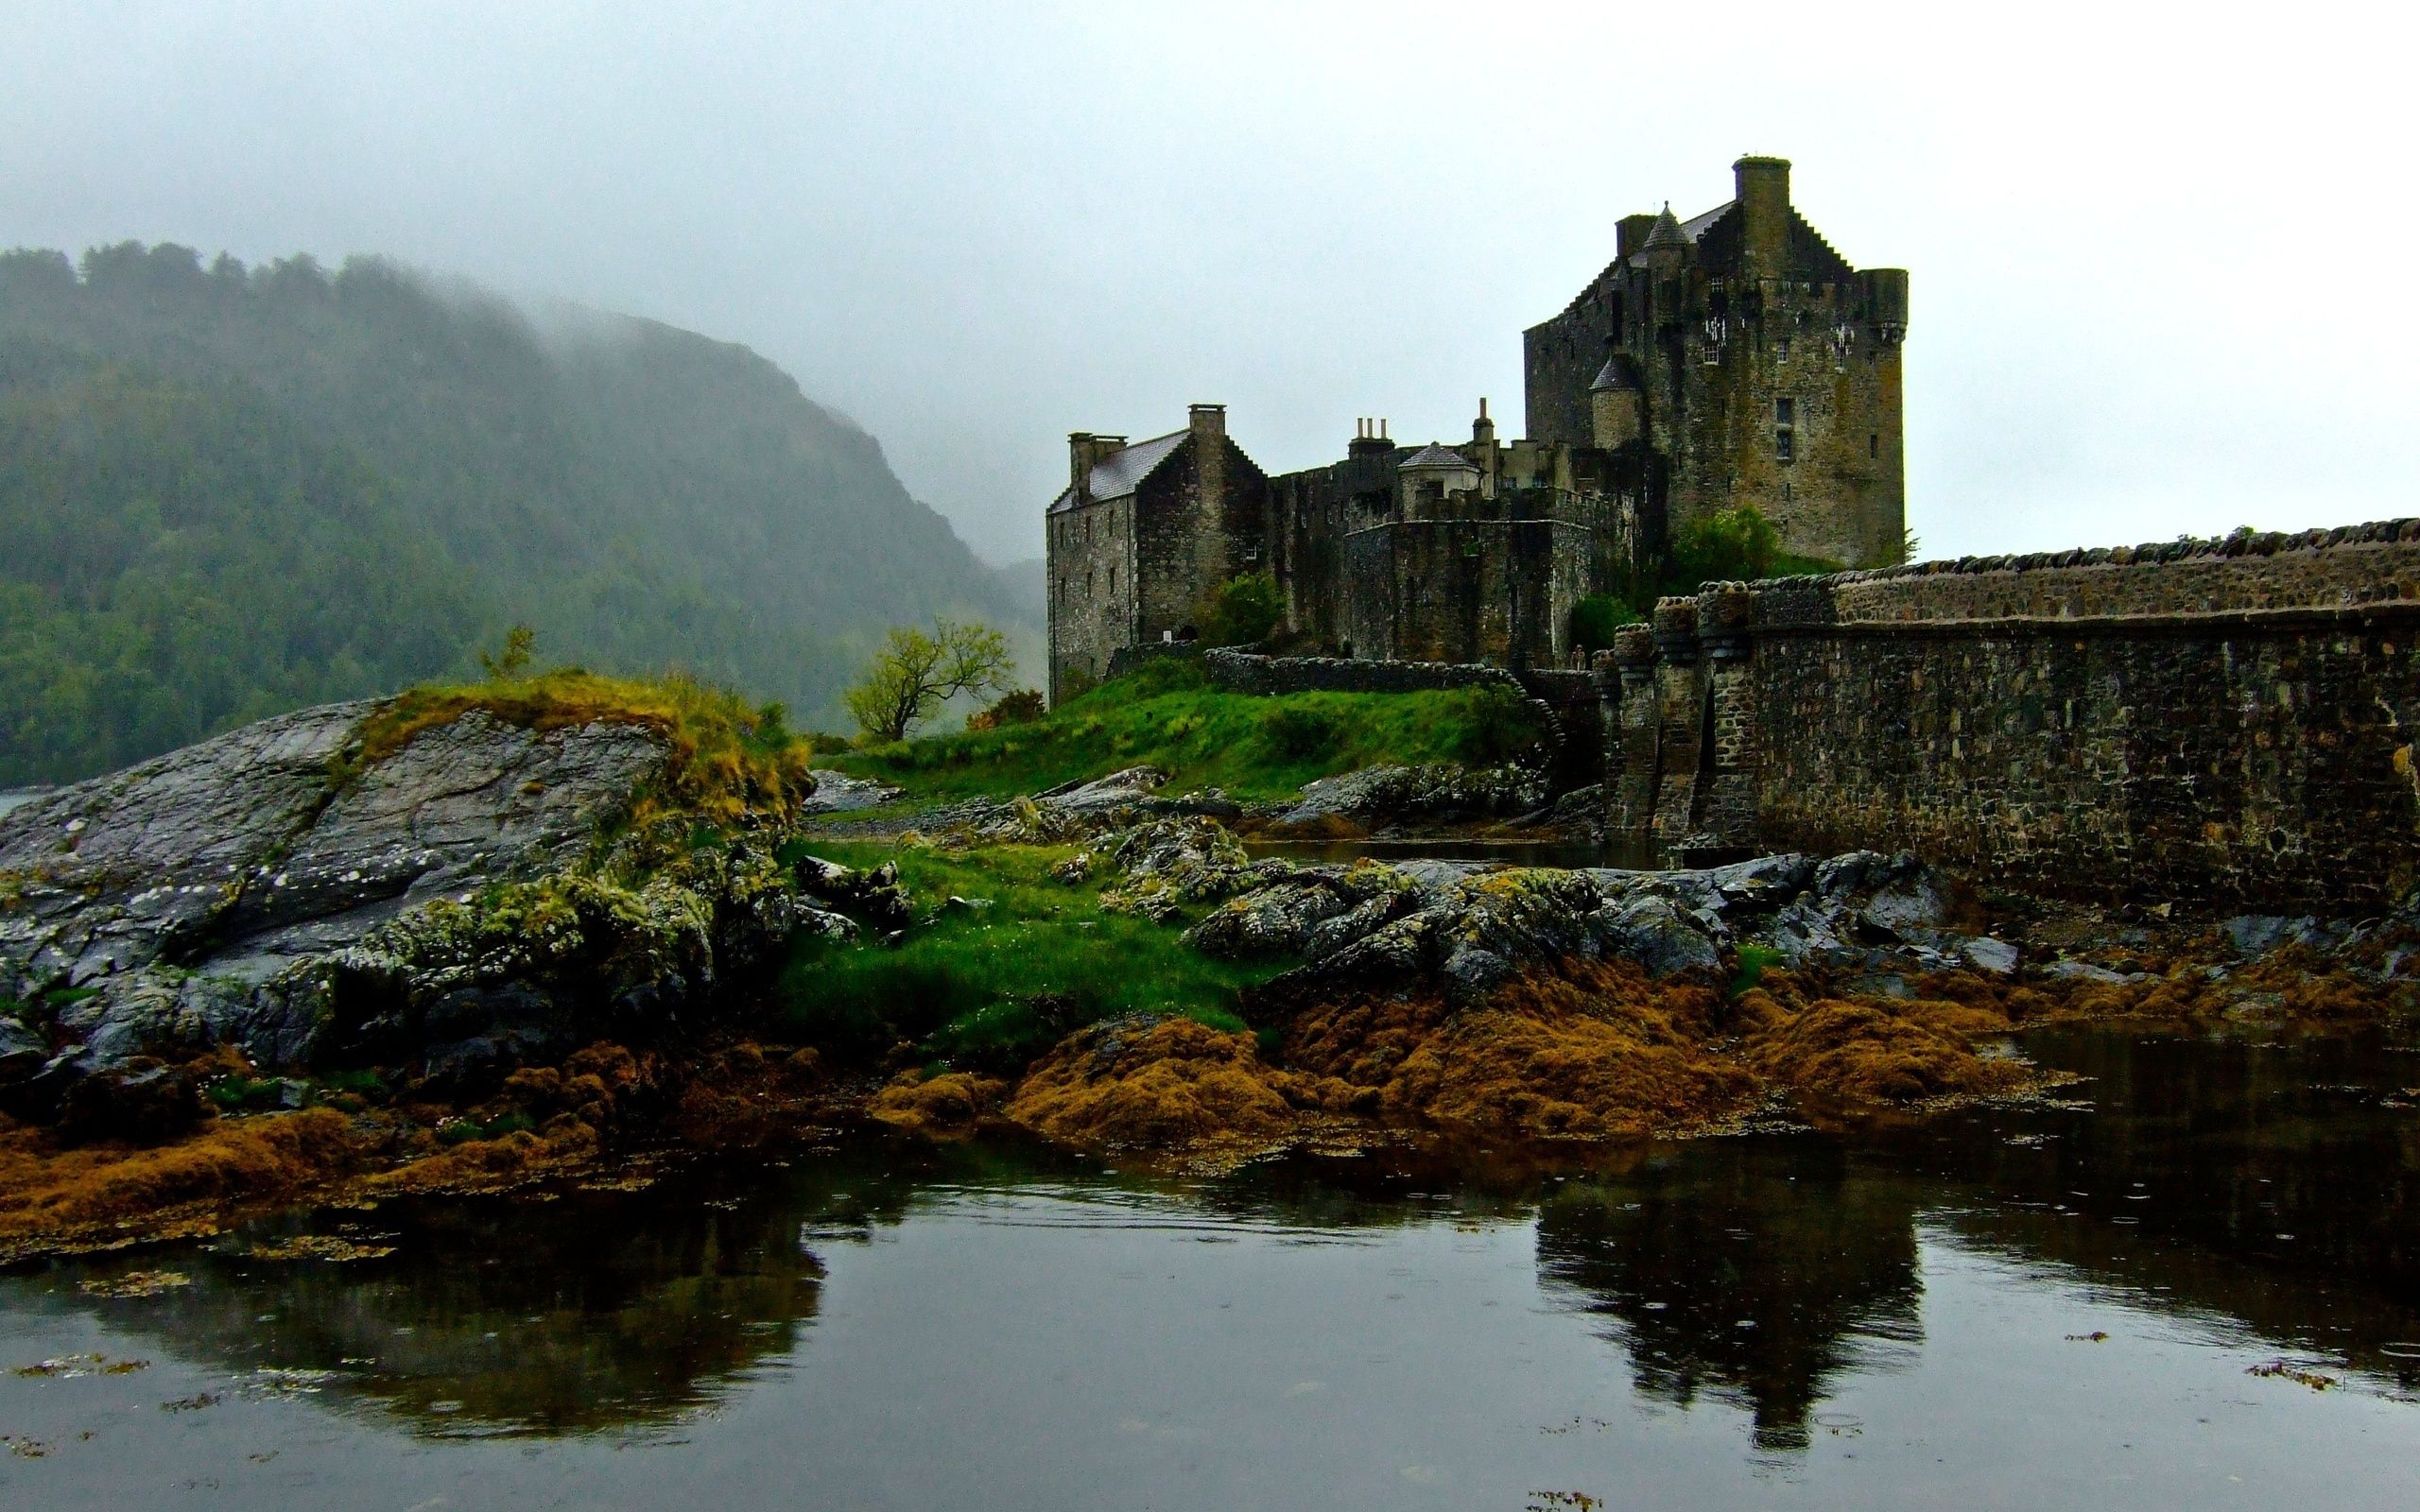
left=0, top=0, right=2420, bottom=558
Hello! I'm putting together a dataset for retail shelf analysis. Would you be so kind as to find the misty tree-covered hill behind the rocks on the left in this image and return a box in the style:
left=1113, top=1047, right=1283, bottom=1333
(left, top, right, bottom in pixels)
left=0, top=245, right=1041, bottom=786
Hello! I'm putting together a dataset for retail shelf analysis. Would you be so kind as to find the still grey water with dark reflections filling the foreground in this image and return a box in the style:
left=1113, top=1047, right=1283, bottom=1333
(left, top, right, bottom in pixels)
left=0, top=1031, right=2420, bottom=1512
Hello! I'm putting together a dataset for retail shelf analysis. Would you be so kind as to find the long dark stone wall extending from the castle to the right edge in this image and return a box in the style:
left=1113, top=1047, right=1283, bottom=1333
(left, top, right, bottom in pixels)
left=1598, top=520, right=2420, bottom=910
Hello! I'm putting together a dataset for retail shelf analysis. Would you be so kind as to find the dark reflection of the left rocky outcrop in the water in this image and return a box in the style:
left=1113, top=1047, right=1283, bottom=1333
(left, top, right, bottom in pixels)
left=53, top=1156, right=847, bottom=1435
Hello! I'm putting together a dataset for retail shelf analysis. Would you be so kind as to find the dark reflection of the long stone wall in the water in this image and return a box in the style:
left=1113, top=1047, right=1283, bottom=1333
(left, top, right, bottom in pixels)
left=1871, top=1028, right=2420, bottom=1394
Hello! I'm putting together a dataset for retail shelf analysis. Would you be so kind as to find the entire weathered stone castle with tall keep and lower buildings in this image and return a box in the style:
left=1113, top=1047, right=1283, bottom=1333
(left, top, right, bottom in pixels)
left=1046, top=157, right=1907, bottom=701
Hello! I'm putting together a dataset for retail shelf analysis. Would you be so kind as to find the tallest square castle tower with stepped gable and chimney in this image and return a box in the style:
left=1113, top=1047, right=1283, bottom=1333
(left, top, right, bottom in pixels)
left=1522, top=157, right=1907, bottom=566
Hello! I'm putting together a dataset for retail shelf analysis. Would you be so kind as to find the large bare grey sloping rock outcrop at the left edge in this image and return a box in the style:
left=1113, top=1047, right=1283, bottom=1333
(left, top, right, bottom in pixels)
left=0, top=704, right=847, bottom=1115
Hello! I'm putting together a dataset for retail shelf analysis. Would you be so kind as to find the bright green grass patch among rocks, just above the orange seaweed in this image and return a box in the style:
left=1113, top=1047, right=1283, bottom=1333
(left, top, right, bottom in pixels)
left=777, top=842, right=1283, bottom=1070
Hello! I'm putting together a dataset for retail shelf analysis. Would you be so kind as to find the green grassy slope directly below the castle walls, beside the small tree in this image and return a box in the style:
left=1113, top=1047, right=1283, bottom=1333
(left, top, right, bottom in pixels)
left=825, top=658, right=1537, bottom=800
